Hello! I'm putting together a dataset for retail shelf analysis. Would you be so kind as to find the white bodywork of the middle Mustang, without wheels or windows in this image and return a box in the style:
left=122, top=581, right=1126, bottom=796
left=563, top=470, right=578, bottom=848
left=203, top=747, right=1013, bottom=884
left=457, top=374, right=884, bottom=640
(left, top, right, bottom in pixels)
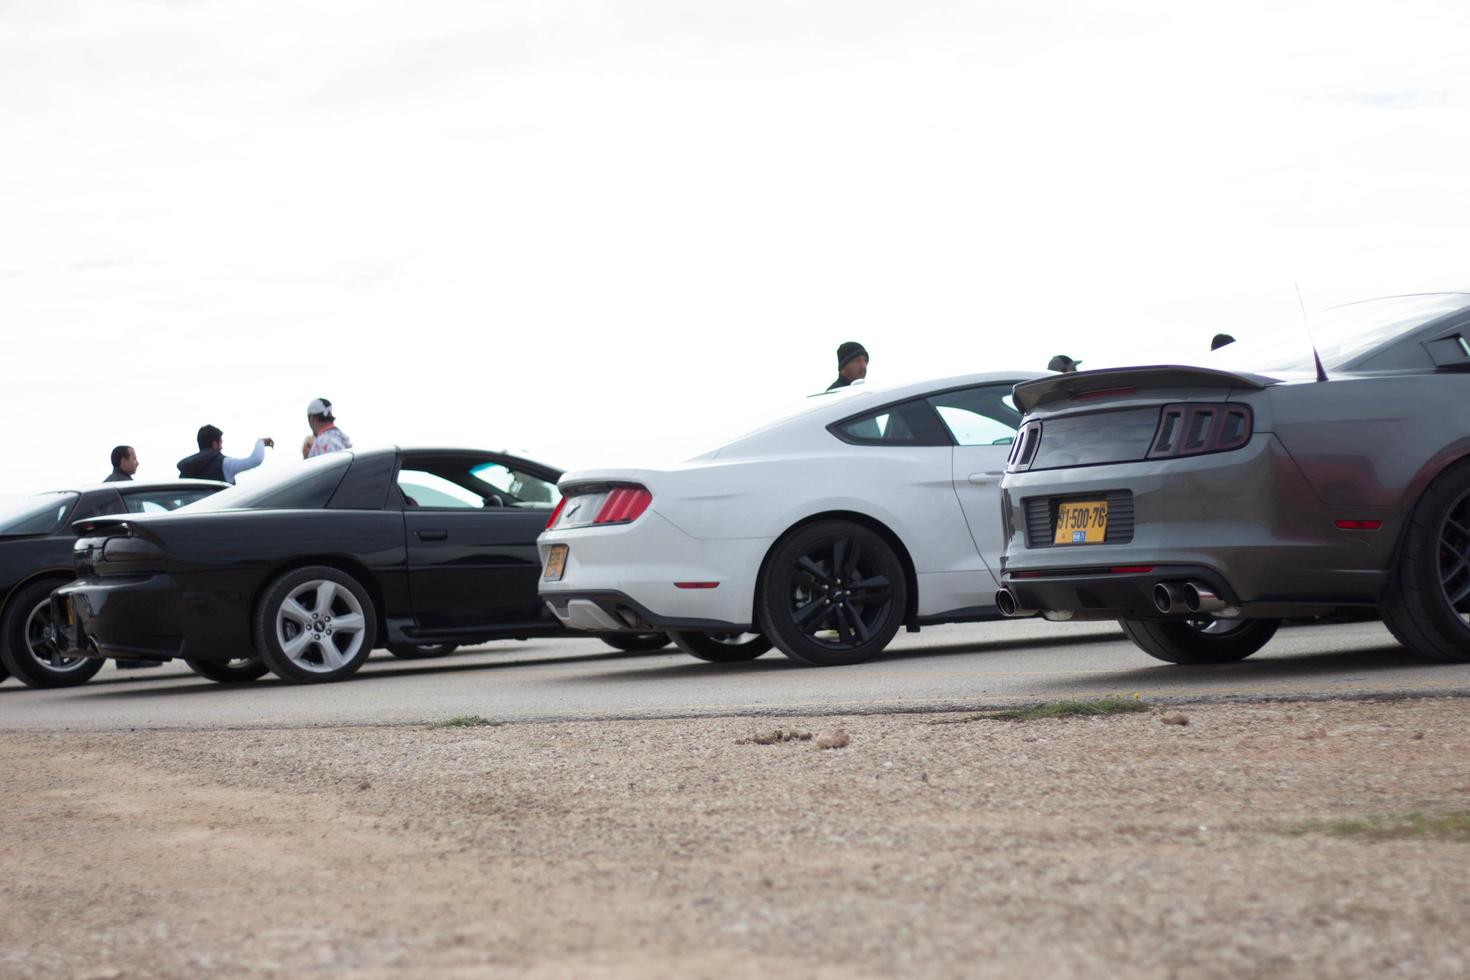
left=538, top=372, right=1039, bottom=632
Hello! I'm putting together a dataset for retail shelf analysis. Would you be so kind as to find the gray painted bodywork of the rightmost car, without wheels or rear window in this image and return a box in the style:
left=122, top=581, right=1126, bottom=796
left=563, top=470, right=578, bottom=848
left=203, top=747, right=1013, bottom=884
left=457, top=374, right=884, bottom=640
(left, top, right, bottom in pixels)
left=1001, top=294, right=1470, bottom=619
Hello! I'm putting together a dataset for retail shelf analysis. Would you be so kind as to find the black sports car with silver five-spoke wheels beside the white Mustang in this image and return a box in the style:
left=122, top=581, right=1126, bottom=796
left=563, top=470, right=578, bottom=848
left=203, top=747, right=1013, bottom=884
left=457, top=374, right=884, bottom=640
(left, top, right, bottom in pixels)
left=54, top=450, right=667, bottom=682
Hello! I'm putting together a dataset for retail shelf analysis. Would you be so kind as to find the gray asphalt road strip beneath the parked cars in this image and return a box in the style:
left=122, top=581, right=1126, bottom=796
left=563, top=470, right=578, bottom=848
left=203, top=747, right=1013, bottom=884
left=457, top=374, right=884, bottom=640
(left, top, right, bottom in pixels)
left=0, top=620, right=1470, bottom=730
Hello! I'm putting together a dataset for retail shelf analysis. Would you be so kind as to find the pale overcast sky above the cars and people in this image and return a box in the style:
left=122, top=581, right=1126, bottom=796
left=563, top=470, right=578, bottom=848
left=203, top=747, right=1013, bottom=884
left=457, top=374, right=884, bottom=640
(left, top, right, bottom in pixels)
left=0, top=0, right=1470, bottom=495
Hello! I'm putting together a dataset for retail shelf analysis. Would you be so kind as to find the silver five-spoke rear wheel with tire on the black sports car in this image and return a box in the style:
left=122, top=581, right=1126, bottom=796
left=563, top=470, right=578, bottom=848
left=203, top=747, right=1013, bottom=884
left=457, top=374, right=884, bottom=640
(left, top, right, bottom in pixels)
left=254, top=566, right=378, bottom=683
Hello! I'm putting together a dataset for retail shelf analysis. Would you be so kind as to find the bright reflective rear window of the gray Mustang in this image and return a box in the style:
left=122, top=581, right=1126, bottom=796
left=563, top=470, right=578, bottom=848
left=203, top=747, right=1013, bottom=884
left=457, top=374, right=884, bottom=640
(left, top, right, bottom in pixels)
left=1198, top=292, right=1470, bottom=375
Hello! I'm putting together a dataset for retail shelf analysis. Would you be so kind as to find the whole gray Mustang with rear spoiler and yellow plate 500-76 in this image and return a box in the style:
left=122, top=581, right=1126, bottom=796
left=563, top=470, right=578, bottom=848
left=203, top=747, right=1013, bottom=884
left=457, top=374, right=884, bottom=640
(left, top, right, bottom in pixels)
left=997, top=292, right=1470, bottom=664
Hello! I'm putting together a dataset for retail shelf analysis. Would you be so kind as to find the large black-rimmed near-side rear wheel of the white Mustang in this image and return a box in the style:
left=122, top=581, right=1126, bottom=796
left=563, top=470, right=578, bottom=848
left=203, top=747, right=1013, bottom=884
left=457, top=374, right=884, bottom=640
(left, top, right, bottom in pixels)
left=756, top=520, right=908, bottom=667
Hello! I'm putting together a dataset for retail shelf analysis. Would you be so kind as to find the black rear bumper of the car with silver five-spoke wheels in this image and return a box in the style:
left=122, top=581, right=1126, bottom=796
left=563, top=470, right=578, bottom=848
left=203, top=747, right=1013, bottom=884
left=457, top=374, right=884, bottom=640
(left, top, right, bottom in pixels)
left=51, top=574, right=251, bottom=660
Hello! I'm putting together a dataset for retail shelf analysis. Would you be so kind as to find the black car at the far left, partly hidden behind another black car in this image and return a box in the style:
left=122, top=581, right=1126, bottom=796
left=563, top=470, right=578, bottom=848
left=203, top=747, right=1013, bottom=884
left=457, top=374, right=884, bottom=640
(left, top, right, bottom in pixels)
left=0, top=480, right=228, bottom=688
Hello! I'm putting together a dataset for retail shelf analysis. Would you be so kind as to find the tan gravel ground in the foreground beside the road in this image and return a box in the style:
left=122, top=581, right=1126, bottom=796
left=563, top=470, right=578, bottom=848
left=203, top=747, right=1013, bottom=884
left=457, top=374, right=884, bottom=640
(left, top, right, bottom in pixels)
left=0, top=699, right=1470, bottom=979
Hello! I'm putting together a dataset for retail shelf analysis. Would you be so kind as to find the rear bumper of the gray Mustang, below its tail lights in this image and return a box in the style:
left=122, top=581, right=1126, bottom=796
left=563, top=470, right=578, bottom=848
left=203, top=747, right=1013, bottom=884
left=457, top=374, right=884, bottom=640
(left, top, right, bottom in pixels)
left=1001, top=433, right=1402, bottom=617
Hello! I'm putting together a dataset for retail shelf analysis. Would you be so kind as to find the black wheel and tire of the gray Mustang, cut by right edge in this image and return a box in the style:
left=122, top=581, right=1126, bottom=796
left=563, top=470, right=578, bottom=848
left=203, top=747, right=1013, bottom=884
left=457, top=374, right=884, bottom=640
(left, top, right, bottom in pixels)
left=1382, top=464, right=1470, bottom=661
